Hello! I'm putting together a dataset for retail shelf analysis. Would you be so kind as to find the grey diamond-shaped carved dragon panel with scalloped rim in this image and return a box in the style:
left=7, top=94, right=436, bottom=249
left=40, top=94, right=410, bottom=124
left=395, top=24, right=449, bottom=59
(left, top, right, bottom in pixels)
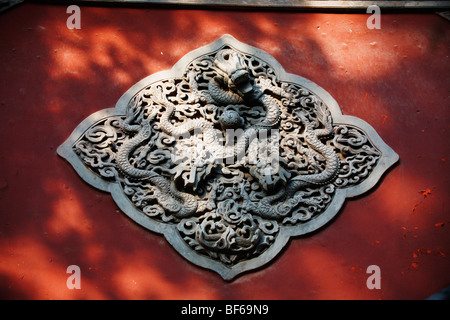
left=58, top=35, right=398, bottom=279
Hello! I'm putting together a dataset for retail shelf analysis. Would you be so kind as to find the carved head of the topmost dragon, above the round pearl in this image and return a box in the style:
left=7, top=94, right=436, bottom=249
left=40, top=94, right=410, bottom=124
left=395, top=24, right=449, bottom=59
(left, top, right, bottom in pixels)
left=214, top=49, right=253, bottom=94
